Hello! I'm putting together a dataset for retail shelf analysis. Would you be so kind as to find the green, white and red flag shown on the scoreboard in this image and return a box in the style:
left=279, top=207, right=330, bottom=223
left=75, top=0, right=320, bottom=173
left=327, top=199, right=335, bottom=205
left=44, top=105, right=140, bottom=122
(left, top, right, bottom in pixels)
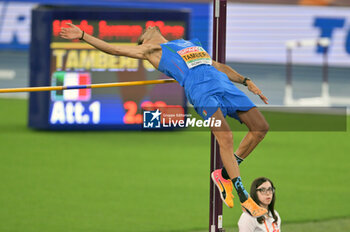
left=51, top=71, right=91, bottom=101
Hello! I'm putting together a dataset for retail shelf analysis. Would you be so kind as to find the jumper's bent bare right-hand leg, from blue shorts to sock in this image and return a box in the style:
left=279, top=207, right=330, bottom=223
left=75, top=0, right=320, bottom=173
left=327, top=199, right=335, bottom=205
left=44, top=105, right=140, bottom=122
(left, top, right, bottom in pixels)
left=236, top=107, right=269, bottom=159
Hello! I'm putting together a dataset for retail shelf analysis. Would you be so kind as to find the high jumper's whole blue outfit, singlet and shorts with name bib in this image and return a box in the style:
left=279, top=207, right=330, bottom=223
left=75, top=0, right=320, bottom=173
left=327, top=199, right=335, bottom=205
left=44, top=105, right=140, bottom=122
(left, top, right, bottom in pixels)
left=158, top=39, right=255, bottom=121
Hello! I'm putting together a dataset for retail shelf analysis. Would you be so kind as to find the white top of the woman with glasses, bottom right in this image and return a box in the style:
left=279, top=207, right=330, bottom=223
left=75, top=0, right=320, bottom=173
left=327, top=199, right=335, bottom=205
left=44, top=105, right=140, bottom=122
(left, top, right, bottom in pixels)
left=238, top=210, right=281, bottom=232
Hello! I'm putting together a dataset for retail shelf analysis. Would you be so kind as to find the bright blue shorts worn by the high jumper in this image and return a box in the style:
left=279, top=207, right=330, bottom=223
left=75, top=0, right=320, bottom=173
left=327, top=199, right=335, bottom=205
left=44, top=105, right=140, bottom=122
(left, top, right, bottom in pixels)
left=184, top=65, right=255, bottom=123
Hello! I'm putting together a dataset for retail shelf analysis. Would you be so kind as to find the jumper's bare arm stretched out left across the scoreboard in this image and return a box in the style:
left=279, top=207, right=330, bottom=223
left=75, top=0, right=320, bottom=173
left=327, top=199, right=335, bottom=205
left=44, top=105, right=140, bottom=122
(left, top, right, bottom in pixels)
left=60, top=23, right=161, bottom=68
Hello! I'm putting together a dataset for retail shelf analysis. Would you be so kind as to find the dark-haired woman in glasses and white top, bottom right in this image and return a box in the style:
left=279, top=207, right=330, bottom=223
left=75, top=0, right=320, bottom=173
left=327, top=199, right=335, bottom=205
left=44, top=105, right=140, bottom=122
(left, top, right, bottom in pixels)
left=238, top=177, right=281, bottom=232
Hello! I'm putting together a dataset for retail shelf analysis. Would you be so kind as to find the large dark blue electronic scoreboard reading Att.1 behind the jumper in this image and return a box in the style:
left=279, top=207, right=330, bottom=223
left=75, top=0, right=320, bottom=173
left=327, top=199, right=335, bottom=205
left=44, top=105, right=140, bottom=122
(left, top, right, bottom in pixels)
left=29, top=6, right=189, bottom=130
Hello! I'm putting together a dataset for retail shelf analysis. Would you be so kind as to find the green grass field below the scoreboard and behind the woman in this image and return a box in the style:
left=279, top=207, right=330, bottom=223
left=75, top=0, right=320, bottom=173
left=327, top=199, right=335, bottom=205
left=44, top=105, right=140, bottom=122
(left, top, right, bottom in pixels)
left=0, top=99, right=350, bottom=232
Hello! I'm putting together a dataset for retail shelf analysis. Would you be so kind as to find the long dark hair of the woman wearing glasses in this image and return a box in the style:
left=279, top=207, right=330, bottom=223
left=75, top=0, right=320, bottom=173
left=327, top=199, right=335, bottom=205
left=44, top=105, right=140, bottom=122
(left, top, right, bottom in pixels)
left=250, top=177, right=278, bottom=224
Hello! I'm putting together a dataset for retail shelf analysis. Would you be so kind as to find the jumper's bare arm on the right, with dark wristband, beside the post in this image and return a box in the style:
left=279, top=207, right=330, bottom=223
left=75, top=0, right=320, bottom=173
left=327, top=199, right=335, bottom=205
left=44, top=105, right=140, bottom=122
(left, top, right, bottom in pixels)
left=213, top=60, right=268, bottom=104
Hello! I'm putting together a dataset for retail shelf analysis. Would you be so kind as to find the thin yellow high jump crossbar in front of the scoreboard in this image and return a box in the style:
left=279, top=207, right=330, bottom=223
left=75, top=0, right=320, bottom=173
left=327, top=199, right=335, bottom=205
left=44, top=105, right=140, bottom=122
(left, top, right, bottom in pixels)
left=0, top=79, right=176, bottom=93
